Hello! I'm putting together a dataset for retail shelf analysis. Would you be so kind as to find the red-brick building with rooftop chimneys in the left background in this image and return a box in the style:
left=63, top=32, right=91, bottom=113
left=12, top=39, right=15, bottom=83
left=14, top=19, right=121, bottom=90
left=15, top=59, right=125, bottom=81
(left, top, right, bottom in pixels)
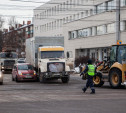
left=2, top=21, right=33, bottom=57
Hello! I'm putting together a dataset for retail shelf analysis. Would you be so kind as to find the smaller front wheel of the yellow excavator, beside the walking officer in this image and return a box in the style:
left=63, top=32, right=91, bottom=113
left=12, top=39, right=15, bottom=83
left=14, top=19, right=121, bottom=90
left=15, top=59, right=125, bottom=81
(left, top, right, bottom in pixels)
left=93, top=73, right=104, bottom=87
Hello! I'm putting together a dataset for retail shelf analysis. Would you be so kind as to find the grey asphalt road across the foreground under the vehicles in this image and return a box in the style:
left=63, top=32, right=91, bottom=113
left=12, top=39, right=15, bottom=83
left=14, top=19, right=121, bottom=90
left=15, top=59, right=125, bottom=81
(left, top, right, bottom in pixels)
left=0, top=74, right=126, bottom=113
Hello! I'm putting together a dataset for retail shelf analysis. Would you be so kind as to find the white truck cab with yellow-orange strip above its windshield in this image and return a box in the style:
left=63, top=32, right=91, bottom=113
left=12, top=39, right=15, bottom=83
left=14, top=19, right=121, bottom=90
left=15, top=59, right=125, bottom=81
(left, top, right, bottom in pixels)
left=38, top=46, right=70, bottom=83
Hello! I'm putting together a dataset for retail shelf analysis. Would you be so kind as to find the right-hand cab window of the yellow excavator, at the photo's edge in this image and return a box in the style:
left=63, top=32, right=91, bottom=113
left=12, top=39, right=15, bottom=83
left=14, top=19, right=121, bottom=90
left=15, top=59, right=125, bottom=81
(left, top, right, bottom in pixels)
left=117, top=46, right=126, bottom=64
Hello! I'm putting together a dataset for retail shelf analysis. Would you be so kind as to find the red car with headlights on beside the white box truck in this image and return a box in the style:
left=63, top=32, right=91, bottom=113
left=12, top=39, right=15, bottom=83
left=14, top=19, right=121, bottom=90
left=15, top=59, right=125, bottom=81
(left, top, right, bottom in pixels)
left=12, top=63, right=37, bottom=82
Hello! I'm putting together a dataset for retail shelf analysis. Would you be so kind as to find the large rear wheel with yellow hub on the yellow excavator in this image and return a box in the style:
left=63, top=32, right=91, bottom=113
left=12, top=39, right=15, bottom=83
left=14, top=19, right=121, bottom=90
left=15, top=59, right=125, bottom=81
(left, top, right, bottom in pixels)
left=109, top=69, right=122, bottom=88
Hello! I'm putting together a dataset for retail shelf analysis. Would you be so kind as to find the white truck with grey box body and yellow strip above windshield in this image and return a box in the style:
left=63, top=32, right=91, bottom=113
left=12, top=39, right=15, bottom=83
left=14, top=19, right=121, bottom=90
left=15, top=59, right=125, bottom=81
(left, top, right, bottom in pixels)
left=26, top=37, right=70, bottom=83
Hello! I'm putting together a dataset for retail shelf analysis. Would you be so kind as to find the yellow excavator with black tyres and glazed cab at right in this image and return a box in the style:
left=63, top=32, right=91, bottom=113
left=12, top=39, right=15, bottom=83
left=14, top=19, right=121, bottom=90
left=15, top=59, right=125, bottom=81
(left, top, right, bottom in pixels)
left=93, top=44, right=126, bottom=88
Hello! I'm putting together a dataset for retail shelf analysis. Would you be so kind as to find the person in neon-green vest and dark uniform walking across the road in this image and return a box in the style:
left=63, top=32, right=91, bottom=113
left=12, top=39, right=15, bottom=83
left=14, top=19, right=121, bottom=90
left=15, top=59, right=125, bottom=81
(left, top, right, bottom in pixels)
left=80, top=59, right=96, bottom=94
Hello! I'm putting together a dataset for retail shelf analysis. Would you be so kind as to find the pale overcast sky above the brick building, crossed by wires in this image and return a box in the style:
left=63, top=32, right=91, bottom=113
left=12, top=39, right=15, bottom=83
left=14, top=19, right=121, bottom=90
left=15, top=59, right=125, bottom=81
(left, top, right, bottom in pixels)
left=0, top=0, right=50, bottom=28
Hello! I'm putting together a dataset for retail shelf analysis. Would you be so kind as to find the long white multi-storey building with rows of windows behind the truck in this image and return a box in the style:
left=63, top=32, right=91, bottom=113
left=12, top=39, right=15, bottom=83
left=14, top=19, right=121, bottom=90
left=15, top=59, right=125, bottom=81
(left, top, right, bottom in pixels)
left=34, top=0, right=126, bottom=60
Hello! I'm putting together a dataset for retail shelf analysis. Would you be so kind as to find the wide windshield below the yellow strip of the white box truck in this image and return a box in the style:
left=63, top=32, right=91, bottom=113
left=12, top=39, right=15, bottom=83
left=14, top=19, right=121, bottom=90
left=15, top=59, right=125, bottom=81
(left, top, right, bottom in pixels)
left=41, top=51, right=64, bottom=59
